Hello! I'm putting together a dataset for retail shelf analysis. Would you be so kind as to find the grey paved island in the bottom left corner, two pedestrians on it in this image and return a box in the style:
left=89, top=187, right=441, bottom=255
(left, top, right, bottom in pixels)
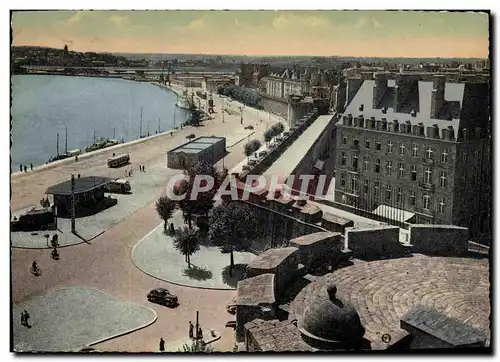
left=12, top=287, right=157, bottom=352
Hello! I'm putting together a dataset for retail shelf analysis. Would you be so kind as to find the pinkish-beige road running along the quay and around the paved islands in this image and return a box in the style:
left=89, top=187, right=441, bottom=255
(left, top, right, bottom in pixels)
left=11, top=86, right=286, bottom=352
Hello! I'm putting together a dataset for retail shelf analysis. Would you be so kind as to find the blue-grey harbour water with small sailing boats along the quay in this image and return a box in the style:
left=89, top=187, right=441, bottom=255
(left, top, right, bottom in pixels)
left=11, top=75, right=188, bottom=171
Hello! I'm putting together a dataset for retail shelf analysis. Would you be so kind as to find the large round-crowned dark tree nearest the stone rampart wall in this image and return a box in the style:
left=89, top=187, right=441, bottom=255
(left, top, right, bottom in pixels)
left=208, top=201, right=258, bottom=276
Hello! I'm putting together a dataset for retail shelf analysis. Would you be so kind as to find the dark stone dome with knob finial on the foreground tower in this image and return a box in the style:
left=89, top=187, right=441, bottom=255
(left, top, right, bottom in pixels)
left=299, top=285, right=365, bottom=349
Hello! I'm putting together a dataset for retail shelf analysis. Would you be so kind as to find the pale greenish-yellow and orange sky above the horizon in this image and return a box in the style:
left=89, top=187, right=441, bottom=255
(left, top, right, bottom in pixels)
left=12, top=10, right=489, bottom=58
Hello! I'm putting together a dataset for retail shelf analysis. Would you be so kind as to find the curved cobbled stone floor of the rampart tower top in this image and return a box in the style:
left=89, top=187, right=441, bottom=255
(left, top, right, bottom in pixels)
left=289, top=254, right=490, bottom=350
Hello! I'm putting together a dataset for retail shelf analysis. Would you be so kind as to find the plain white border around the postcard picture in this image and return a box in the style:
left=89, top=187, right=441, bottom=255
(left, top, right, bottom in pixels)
left=0, top=0, right=500, bottom=361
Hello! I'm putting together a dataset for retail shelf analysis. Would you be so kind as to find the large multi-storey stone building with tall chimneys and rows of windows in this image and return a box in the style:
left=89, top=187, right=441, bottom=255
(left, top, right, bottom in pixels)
left=335, top=73, right=491, bottom=235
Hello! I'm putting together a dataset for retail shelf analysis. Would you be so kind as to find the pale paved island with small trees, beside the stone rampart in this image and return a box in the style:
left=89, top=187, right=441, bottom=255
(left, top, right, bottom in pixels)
left=132, top=213, right=255, bottom=289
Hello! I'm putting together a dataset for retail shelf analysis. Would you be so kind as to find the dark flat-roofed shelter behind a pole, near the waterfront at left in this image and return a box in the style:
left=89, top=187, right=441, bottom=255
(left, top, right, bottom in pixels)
left=45, top=176, right=113, bottom=216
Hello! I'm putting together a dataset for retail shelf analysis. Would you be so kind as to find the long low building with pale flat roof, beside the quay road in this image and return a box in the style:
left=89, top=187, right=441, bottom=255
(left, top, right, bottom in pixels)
left=167, top=136, right=226, bottom=169
